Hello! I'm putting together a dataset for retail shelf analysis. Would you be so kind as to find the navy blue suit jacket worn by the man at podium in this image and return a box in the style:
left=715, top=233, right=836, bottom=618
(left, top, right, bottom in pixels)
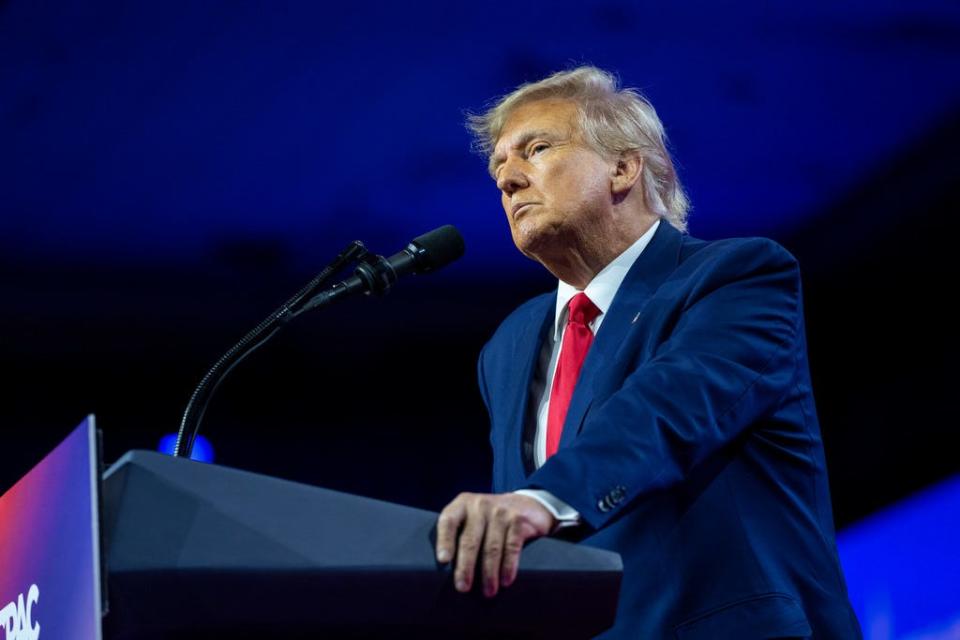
left=479, top=221, right=861, bottom=640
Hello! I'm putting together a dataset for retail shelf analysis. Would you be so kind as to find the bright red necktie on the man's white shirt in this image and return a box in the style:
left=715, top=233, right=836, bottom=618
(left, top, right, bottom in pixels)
left=546, top=293, right=600, bottom=458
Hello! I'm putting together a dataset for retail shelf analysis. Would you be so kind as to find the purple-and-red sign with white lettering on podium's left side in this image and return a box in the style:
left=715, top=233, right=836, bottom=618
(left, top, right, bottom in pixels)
left=0, top=416, right=102, bottom=640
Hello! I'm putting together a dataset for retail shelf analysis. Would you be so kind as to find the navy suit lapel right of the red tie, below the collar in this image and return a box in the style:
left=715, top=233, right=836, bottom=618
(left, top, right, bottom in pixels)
left=560, top=220, right=683, bottom=449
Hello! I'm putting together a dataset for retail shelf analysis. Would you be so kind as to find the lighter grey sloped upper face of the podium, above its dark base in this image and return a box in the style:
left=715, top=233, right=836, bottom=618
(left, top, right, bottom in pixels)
left=104, top=451, right=622, bottom=573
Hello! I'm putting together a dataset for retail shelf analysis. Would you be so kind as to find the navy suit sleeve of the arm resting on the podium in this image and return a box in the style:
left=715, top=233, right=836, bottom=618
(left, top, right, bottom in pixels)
left=529, top=240, right=802, bottom=528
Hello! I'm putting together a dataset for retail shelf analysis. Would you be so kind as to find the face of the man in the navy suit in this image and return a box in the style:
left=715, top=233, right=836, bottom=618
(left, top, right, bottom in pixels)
left=490, top=100, right=615, bottom=262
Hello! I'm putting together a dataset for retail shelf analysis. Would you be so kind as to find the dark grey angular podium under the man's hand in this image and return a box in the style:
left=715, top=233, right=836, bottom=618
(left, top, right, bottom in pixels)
left=102, top=451, right=622, bottom=640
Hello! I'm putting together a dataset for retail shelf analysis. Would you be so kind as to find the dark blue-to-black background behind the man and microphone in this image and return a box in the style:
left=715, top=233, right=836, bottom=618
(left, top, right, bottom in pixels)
left=0, top=0, right=960, bottom=526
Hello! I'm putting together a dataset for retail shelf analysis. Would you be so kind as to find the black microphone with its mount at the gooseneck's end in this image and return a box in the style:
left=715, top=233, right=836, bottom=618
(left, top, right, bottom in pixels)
left=296, top=224, right=465, bottom=315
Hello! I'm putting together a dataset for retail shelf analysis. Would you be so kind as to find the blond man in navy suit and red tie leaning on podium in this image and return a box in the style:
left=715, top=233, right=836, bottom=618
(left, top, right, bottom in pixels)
left=437, top=67, right=860, bottom=640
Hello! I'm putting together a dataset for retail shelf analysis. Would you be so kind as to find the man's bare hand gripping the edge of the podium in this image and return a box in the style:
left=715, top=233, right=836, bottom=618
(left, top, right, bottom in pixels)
left=437, top=493, right=556, bottom=598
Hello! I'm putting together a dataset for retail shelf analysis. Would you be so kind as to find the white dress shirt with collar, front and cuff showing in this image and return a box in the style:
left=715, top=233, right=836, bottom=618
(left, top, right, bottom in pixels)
left=516, top=220, right=660, bottom=527
